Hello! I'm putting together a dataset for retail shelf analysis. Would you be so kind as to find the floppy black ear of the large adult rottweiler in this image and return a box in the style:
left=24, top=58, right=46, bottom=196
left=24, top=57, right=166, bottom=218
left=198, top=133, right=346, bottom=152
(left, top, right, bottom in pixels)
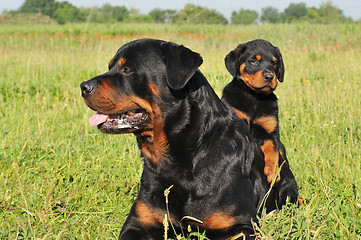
left=161, top=42, right=203, bottom=90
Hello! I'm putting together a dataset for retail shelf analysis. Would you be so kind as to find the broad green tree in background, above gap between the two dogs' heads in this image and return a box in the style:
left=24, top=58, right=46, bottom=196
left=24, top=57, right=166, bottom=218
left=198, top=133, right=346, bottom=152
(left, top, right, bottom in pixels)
left=179, top=4, right=228, bottom=24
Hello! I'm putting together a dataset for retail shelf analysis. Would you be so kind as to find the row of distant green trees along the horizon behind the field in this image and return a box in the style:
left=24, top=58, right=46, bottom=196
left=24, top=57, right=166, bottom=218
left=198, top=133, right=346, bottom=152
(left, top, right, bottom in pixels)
left=7, top=0, right=353, bottom=25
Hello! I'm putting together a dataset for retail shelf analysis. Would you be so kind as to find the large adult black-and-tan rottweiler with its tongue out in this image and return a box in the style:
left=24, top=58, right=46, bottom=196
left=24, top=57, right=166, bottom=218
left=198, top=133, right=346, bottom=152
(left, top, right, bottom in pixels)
left=81, top=39, right=267, bottom=240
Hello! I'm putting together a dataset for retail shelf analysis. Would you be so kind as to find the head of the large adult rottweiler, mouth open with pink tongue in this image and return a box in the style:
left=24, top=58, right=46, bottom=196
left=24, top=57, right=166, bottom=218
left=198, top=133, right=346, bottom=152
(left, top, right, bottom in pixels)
left=80, top=39, right=202, bottom=134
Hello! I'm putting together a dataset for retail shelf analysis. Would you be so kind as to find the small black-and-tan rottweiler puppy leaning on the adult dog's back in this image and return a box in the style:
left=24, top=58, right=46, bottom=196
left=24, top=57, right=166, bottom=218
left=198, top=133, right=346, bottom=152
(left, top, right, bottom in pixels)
left=222, top=39, right=298, bottom=210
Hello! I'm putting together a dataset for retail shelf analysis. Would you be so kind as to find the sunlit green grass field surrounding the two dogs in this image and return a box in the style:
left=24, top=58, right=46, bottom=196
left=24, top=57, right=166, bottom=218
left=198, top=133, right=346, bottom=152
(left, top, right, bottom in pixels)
left=0, top=24, right=361, bottom=239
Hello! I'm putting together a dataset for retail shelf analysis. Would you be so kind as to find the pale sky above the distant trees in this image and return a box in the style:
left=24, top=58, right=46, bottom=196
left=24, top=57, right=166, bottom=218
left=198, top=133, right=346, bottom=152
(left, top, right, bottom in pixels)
left=0, top=0, right=361, bottom=20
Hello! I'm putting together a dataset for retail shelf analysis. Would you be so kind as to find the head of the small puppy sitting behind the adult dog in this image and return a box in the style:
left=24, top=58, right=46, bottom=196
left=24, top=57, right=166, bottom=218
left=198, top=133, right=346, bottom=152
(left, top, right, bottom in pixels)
left=225, top=39, right=285, bottom=93
